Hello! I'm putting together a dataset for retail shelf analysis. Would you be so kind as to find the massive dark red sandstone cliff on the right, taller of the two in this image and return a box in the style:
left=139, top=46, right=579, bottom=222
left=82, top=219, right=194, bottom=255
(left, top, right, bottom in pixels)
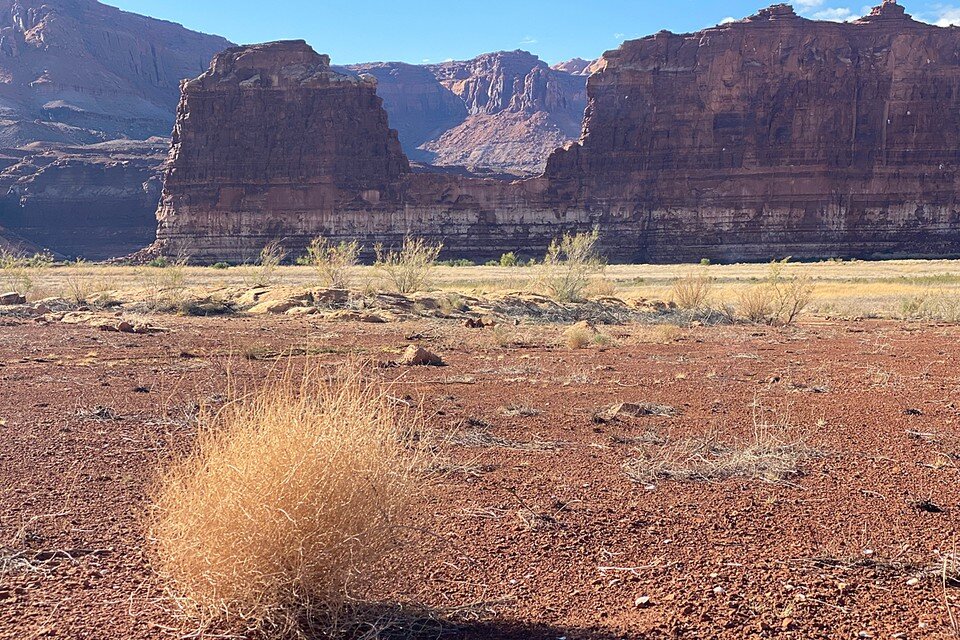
left=547, top=0, right=960, bottom=260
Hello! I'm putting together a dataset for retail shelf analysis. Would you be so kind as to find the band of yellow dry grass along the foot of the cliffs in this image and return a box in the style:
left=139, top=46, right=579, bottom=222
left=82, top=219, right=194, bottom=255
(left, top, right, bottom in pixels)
left=15, top=260, right=960, bottom=319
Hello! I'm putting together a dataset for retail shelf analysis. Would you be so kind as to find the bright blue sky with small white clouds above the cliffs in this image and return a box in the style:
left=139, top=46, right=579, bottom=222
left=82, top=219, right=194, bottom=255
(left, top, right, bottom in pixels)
left=105, top=0, right=960, bottom=64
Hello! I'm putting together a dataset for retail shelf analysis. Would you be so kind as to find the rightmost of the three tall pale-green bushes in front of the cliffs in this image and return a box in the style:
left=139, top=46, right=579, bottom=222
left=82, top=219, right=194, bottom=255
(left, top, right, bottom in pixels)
left=537, top=229, right=606, bottom=302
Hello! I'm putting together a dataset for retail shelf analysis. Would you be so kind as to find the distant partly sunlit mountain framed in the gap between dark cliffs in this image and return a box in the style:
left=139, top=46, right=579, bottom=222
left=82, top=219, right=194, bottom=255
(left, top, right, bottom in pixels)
left=349, top=51, right=586, bottom=175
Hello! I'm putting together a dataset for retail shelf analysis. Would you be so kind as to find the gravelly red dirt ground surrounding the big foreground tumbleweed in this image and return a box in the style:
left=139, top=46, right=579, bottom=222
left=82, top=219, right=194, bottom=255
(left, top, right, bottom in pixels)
left=0, top=317, right=960, bottom=640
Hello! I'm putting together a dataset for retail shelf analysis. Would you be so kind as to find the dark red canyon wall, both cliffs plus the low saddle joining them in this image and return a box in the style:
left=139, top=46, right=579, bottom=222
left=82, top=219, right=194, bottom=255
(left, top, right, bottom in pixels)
left=155, top=1, right=960, bottom=262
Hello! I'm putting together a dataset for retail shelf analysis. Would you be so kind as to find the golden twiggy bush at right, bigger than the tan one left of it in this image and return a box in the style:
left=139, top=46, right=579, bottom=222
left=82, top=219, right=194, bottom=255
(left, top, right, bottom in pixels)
left=737, top=260, right=813, bottom=326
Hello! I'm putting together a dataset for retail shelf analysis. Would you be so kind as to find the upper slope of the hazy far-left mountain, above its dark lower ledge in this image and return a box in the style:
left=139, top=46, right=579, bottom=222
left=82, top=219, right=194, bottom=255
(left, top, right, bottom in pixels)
left=0, top=0, right=230, bottom=147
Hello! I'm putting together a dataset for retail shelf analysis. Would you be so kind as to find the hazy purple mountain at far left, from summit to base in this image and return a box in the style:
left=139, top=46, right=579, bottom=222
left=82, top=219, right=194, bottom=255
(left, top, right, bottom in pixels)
left=0, top=0, right=230, bottom=259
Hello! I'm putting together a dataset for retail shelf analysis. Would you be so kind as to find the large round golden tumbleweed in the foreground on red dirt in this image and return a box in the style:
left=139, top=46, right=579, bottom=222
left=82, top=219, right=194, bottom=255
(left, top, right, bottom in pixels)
left=149, top=365, right=417, bottom=632
